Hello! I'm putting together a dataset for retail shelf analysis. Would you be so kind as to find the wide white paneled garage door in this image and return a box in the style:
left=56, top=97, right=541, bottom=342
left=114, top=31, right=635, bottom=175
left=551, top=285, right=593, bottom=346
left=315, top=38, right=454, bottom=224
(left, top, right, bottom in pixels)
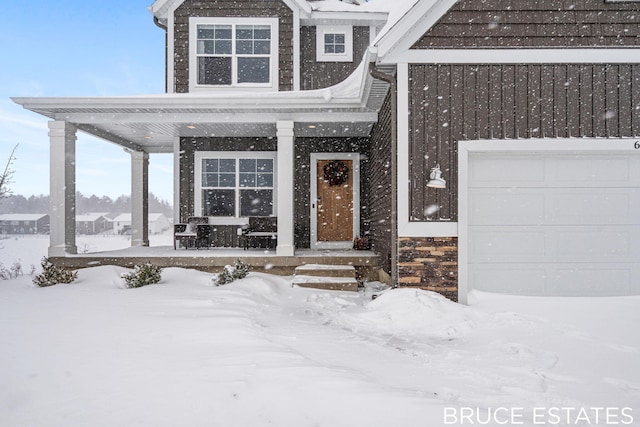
left=467, top=151, right=640, bottom=296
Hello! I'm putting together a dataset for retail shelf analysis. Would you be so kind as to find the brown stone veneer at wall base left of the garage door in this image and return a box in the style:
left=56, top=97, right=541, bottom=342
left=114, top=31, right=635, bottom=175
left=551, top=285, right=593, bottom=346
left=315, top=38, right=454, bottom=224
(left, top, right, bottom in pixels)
left=398, top=237, right=458, bottom=301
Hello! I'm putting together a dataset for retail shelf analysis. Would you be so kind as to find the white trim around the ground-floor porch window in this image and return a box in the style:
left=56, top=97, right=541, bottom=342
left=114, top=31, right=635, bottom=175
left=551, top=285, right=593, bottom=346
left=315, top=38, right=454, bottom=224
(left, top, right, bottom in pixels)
left=193, top=151, right=278, bottom=223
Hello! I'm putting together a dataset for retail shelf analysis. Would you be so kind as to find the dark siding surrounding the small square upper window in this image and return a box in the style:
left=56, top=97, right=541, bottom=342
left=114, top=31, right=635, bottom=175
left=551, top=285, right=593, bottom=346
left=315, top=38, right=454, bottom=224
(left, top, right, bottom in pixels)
left=300, top=26, right=369, bottom=90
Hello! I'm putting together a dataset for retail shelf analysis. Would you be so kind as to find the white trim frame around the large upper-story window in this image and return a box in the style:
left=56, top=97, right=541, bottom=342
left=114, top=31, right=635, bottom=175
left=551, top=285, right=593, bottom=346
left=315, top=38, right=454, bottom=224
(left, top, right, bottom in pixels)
left=189, top=17, right=280, bottom=92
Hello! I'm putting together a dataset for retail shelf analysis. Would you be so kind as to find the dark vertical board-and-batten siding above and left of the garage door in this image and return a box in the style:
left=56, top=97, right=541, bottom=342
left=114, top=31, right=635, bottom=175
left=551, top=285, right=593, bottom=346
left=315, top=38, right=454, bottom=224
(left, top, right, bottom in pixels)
left=409, top=64, right=640, bottom=221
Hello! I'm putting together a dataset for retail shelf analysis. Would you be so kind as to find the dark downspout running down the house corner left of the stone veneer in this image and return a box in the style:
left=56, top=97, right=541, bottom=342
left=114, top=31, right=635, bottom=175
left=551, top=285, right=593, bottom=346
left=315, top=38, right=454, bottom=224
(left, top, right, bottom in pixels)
left=369, top=62, right=398, bottom=288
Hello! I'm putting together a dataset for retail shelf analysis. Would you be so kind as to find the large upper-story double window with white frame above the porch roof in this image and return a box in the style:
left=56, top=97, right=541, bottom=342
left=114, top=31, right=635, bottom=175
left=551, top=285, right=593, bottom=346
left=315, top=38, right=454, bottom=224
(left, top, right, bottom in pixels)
left=189, top=18, right=278, bottom=90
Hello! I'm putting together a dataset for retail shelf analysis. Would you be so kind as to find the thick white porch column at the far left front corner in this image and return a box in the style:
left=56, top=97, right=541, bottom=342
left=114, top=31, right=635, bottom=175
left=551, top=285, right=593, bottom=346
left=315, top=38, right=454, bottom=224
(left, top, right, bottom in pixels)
left=49, top=121, right=78, bottom=257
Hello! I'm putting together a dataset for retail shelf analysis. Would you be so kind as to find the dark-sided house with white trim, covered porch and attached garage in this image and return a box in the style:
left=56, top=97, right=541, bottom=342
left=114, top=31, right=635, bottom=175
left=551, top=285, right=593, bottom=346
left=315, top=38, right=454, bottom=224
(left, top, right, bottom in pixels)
left=15, top=0, right=640, bottom=302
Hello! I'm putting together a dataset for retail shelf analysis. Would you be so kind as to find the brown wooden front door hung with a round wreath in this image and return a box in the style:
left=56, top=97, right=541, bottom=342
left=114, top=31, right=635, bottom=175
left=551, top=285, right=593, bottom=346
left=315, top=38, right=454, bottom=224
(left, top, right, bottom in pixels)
left=317, top=160, right=354, bottom=242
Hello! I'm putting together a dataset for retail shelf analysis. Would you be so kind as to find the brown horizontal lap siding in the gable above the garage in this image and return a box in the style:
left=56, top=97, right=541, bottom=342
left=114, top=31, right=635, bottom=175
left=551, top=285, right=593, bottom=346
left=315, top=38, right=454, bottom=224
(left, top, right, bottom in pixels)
left=413, top=0, right=640, bottom=49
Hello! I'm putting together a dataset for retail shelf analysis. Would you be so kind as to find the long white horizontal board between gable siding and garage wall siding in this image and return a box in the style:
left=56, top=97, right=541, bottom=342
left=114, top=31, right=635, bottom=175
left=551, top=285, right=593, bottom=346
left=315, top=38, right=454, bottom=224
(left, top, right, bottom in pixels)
left=380, top=47, right=640, bottom=64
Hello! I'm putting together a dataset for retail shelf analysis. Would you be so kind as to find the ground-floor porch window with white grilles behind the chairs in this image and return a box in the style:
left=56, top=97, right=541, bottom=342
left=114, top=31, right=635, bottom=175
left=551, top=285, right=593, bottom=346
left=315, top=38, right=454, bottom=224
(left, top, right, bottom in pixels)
left=196, top=152, right=275, bottom=218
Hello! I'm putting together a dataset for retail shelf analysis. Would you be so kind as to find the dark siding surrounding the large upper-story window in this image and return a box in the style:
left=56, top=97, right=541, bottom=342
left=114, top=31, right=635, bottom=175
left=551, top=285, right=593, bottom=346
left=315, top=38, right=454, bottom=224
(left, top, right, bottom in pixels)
left=173, top=0, right=293, bottom=93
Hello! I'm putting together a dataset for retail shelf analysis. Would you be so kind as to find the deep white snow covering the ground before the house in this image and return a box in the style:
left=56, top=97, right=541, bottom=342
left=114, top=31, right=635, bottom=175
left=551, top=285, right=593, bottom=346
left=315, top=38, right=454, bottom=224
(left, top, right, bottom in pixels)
left=0, top=237, right=640, bottom=427
